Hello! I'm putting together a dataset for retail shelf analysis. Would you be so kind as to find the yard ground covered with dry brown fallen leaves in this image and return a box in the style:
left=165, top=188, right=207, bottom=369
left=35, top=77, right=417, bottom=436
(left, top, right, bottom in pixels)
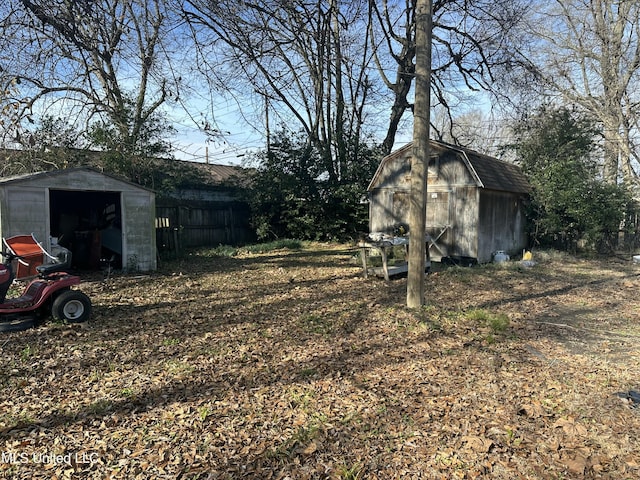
left=0, top=245, right=640, bottom=479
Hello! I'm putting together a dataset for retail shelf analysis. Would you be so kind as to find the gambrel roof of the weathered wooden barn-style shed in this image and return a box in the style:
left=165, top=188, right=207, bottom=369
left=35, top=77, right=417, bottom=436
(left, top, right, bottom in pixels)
left=368, top=140, right=531, bottom=193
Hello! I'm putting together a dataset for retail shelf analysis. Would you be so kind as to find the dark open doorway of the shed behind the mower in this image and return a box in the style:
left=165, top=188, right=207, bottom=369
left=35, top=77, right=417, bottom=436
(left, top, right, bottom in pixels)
left=49, top=190, right=122, bottom=270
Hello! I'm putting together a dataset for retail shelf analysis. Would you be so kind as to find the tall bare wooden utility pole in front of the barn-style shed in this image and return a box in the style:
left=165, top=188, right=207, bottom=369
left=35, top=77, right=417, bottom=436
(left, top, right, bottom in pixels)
left=407, top=0, right=433, bottom=308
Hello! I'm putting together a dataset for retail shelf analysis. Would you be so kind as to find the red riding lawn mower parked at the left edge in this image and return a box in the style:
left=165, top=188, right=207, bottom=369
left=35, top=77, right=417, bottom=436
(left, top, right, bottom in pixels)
left=0, top=235, right=91, bottom=332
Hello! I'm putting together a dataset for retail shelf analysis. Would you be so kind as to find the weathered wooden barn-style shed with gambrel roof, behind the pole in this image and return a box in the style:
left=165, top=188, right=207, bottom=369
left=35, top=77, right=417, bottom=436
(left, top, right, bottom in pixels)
left=368, top=140, right=530, bottom=263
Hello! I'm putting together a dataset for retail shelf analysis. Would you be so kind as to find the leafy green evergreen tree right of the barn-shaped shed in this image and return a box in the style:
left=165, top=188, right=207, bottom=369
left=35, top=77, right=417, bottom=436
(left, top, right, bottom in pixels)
left=513, top=107, right=633, bottom=251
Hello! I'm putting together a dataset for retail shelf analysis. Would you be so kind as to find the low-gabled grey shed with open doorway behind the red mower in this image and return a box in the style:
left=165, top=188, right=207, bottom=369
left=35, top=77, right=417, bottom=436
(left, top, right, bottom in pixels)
left=0, top=167, right=157, bottom=271
